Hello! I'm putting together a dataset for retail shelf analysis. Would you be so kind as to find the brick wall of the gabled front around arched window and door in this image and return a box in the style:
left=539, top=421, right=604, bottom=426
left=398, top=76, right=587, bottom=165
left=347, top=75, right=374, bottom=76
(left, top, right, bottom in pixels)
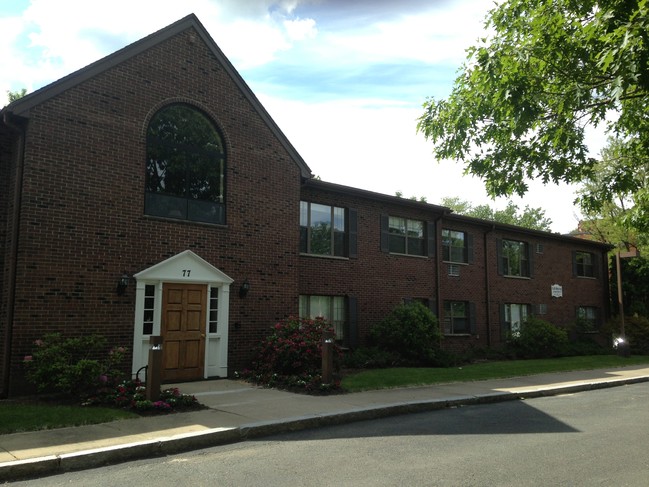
left=3, top=26, right=300, bottom=394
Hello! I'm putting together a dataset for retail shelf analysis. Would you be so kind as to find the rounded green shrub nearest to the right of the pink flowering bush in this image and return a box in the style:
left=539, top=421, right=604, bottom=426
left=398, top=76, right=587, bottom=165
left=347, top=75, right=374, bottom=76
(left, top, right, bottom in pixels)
left=369, top=301, right=442, bottom=365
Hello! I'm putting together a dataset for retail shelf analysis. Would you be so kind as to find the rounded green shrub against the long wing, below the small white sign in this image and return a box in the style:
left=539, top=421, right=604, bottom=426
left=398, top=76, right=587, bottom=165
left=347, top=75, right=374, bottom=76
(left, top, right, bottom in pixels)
left=507, top=317, right=568, bottom=358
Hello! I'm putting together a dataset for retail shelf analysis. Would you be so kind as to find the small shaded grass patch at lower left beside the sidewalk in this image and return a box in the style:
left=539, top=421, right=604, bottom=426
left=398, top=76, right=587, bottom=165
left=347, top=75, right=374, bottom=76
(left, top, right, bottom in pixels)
left=0, top=400, right=139, bottom=434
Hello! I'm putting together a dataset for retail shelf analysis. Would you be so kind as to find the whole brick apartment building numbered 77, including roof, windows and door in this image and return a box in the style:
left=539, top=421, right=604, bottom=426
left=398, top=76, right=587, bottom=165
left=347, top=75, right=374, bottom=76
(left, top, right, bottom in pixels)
left=0, top=15, right=608, bottom=395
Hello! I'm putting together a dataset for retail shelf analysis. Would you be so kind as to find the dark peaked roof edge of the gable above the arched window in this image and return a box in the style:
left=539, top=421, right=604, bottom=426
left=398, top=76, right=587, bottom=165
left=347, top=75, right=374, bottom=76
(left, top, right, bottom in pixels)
left=0, top=14, right=312, bottom=178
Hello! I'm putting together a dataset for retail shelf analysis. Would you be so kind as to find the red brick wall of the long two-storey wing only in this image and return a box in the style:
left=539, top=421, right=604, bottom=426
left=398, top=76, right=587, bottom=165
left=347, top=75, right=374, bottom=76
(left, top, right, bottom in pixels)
left=299, top=193, right=608, bottom=351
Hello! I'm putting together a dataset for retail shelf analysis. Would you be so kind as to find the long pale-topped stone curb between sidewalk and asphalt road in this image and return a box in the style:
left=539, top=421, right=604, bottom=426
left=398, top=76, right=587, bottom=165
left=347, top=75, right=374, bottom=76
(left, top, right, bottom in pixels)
left=0, top=376, right=649, bottom=482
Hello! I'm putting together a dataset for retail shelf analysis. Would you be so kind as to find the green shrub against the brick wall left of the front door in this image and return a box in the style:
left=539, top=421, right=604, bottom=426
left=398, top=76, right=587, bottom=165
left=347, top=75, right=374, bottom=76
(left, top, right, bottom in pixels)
left=23, top=333, right=126, bottom=398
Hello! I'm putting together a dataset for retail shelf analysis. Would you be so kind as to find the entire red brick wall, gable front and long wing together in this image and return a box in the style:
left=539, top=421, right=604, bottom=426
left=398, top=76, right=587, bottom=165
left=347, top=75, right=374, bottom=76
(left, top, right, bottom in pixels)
left=0, top=23, right=606, bottom=396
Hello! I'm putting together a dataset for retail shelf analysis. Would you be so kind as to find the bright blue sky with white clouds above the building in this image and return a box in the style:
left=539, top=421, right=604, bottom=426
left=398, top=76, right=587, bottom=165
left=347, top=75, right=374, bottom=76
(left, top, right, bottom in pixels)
left=0, top=0, right=603, bottom=233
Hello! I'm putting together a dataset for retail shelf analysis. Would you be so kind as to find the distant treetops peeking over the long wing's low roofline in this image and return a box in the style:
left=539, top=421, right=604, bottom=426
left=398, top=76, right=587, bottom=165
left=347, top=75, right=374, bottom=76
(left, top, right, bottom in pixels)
left=441, top=197, right=552, bottom=232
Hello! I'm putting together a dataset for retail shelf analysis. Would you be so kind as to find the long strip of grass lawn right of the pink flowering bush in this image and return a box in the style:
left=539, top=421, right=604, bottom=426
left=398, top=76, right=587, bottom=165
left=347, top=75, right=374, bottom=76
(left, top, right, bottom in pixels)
left=341, top=355, right=649, bottom=392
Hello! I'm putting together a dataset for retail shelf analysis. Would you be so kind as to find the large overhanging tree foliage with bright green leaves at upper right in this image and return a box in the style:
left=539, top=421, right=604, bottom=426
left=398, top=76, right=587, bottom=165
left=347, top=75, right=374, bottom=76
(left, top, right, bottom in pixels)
left=418, top=0, right=649, bottom=230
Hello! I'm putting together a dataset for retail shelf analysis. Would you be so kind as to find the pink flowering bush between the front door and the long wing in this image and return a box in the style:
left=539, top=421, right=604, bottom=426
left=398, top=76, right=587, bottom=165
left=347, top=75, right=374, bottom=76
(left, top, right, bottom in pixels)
left=239, top=317, right=341, bottom=393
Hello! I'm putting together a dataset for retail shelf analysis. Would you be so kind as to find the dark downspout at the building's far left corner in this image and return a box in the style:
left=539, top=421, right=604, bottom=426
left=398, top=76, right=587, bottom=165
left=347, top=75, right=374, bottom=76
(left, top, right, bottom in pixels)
left=0, top=112, right=25, bottom=398
